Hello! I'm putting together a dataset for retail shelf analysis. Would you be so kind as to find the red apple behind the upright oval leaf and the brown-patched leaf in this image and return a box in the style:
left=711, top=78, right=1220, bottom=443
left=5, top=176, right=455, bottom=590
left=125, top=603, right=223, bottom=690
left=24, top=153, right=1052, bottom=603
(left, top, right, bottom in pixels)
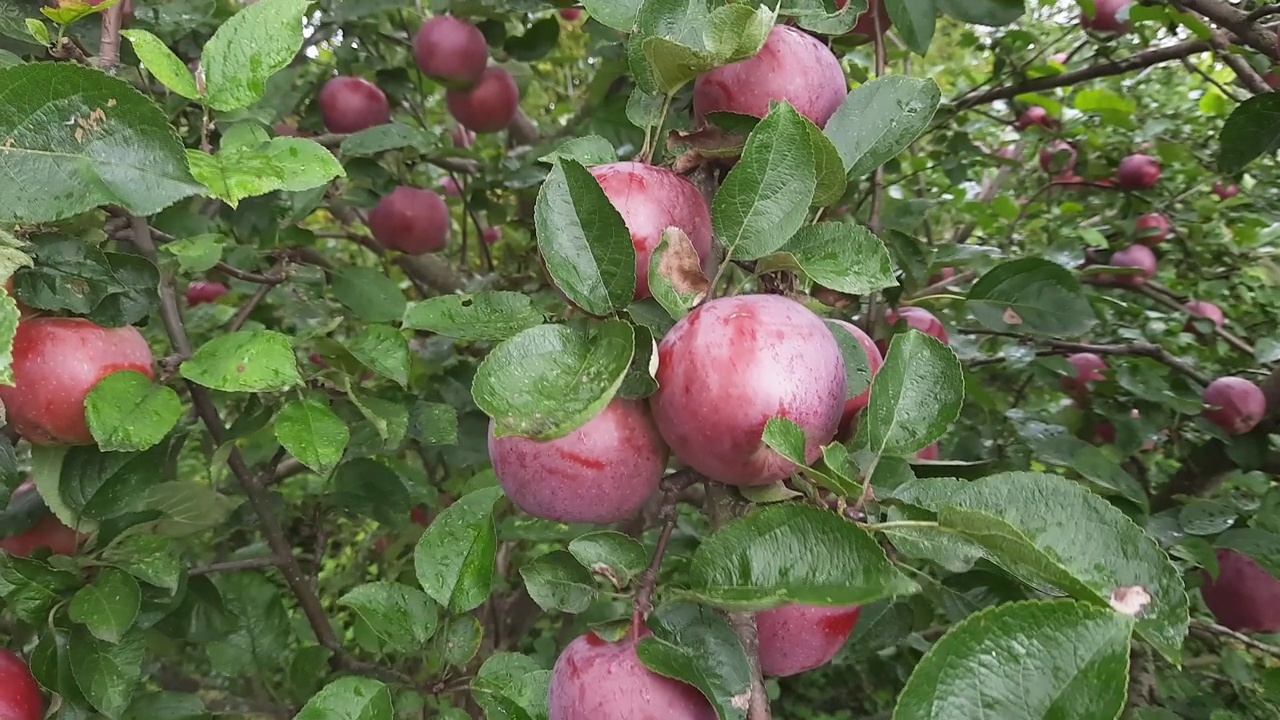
left=590, top=161, right=716, bottom=300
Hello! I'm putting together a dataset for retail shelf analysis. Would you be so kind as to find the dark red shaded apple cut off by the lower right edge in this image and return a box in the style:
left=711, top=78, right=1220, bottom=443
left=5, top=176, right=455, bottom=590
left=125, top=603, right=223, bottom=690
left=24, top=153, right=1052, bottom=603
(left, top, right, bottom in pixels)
left=1201, top=547, right=1280, bottom=633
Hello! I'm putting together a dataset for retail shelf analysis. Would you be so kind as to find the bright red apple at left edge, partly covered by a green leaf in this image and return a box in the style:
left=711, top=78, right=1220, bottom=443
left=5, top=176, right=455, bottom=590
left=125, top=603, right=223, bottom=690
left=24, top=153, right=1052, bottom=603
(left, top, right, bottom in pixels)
left=0, top=318, right=155, bottom=445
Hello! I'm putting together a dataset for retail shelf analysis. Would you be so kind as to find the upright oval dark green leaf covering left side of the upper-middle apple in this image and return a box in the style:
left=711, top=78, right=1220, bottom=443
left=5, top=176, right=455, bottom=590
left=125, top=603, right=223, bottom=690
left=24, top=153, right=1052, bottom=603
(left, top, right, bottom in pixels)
left=534, top=159, right=636, bottom=315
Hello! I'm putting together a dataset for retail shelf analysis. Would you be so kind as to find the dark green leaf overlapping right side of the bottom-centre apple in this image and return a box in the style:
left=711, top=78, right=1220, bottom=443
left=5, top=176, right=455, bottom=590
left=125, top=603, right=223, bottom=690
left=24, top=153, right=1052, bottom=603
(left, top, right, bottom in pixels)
left=636, top=602, right=751, bottom=720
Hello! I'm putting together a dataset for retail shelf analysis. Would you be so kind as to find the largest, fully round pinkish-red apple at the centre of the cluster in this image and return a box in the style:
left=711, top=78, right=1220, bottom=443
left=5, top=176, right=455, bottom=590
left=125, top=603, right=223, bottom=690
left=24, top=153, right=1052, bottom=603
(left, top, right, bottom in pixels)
left=649, top=295, right=845, bottom=486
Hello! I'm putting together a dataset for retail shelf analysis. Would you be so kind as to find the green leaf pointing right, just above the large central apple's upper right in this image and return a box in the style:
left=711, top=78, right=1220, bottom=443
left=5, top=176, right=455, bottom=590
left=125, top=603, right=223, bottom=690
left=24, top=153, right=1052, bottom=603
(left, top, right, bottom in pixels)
left=756, top=222, right=897, bottom=295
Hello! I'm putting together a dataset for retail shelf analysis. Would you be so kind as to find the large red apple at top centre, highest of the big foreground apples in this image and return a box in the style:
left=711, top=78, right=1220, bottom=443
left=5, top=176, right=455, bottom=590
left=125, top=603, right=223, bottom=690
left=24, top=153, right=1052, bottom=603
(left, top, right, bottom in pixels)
left=694, top=26, right=849, bottom=127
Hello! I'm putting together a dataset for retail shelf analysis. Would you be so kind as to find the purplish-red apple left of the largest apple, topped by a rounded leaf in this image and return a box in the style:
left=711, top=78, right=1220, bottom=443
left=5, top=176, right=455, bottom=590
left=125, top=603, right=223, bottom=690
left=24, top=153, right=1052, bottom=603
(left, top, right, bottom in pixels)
left=489, top=397, right=668, bottom=524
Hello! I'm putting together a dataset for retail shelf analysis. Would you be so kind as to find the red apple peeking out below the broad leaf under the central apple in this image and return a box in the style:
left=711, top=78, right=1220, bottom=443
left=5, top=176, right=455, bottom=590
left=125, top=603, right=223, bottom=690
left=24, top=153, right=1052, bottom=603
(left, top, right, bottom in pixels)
left=755, top=603, right=861, bottom=678
